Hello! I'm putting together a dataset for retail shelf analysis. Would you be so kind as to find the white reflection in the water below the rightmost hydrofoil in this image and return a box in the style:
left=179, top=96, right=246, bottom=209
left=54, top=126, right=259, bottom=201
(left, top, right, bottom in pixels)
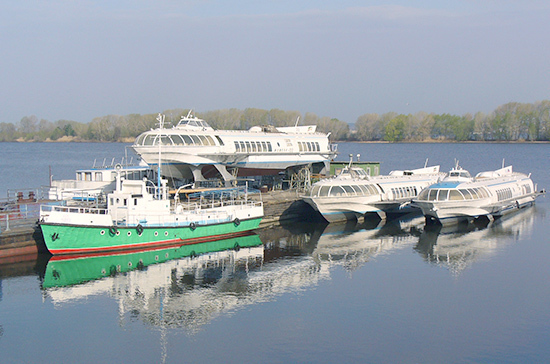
left=414, top=206, right=542, bottom=276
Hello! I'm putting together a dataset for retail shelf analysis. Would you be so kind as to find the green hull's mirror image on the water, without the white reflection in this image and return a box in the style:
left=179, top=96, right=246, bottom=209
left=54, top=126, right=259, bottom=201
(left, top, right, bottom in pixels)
left=42, top=234, right=262, bottom=288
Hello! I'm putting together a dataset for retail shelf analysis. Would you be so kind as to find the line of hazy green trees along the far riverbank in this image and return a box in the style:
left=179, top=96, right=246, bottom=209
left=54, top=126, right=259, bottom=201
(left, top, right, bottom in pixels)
left=0, top=100, right=550, bottom=142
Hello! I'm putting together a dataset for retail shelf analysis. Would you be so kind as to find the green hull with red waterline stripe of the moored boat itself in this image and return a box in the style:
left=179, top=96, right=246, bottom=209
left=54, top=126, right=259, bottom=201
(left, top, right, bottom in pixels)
left=40, top=217, right=261, bottom=255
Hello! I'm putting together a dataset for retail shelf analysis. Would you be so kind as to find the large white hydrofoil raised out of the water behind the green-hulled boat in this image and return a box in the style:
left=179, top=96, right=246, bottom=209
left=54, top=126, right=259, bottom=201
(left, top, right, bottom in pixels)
left=132, top=112, right=336, bottom=185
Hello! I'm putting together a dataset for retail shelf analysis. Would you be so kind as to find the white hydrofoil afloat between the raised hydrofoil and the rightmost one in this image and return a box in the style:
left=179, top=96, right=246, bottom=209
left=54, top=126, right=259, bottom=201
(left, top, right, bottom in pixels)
left=302, top=163, right=444, bottom=222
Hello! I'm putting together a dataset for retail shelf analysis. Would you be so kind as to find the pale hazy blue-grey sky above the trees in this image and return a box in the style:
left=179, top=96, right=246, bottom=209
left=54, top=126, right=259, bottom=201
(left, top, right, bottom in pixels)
left=0, top=0, right=550, bottom=123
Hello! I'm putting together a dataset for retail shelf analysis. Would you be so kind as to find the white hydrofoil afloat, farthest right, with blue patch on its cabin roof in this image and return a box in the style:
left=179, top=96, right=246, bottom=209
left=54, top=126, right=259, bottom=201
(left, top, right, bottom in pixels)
left=413, top=165, right=545, bottom=225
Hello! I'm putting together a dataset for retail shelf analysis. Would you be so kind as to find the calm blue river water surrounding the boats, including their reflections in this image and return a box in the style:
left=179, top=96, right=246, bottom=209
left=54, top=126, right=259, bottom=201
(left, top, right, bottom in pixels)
left=0, top=143, right=550, bottom=363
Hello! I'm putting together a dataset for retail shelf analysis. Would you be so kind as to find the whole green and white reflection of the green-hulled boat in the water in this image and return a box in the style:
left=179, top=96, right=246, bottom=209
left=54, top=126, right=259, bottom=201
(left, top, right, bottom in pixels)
left=42, top=234, right=263, bottom=328
